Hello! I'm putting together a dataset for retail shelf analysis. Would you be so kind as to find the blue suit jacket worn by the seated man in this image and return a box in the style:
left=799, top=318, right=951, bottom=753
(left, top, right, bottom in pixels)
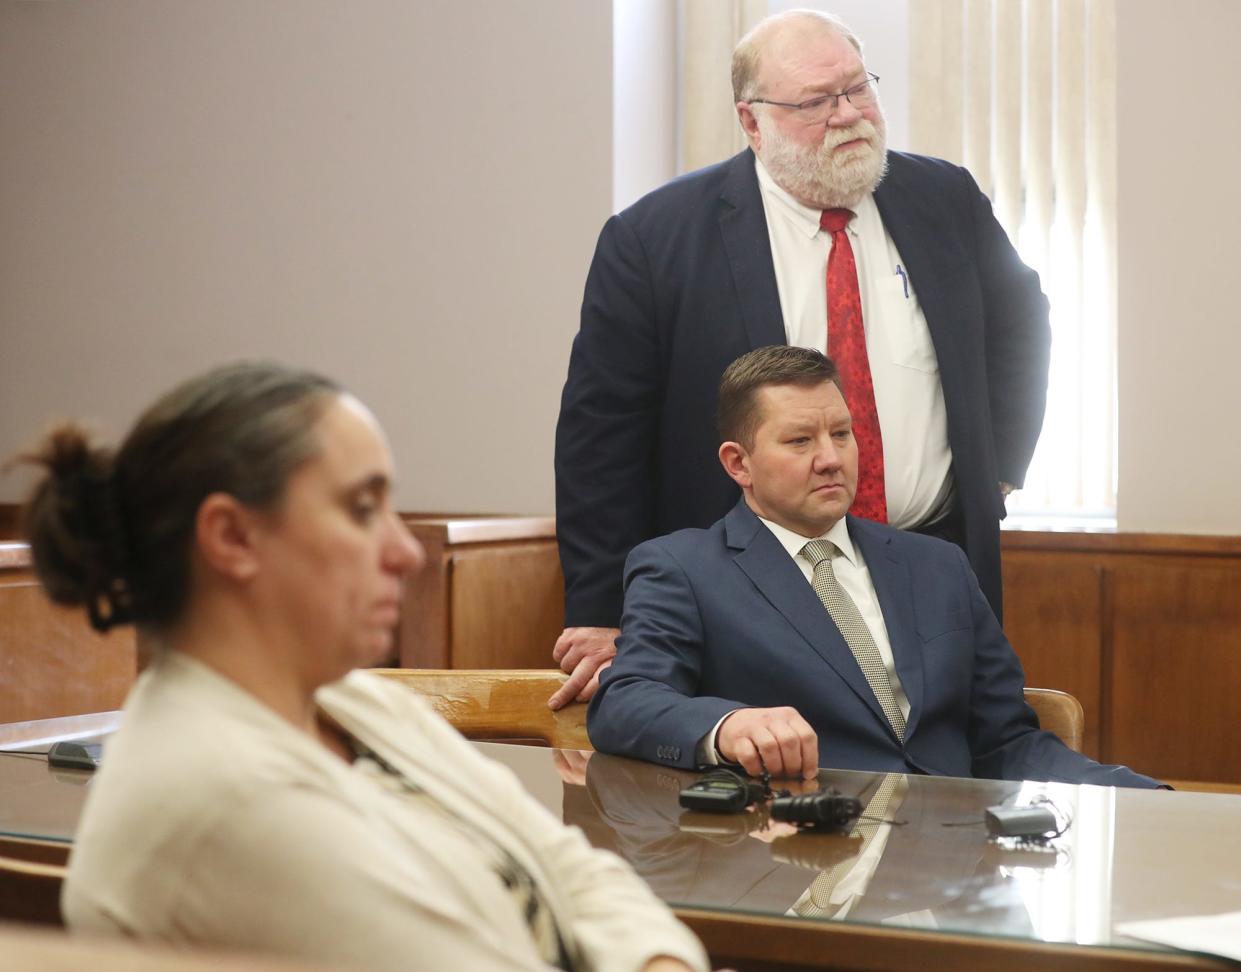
left=587, top=500, right=1158, bottom=787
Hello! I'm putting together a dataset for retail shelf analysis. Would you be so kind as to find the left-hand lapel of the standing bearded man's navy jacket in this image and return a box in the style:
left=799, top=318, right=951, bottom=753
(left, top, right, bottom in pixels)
left=720, top=149, right=784, bottom=348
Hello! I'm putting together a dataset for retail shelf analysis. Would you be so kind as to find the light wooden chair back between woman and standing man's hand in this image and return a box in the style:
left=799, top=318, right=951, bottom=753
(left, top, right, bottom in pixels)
left=374, top=668, right=593, bottom=750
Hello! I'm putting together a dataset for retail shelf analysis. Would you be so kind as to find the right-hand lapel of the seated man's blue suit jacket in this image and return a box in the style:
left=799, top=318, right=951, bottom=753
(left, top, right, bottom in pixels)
left=848, top=516, right=923, bottom=739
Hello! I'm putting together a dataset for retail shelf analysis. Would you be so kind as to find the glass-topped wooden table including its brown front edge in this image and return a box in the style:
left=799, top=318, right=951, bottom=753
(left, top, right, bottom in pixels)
left=0, top=716, right=1241, bottom=972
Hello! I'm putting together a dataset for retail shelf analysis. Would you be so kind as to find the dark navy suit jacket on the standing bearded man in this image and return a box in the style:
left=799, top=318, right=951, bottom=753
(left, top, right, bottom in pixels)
left=556, top=149, right=1050, bottom=627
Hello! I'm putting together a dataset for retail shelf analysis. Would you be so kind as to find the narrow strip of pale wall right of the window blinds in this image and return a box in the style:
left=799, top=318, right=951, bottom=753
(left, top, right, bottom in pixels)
left=1117, top=0, right=1241, bottom=534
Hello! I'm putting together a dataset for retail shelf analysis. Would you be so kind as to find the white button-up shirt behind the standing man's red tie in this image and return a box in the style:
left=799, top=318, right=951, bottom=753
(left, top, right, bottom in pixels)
left=755, top=159, right=952, bottom=528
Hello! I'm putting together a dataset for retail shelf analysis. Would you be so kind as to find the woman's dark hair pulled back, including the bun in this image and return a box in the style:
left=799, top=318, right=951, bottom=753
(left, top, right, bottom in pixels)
left=20, top=362, right=341, bottom=631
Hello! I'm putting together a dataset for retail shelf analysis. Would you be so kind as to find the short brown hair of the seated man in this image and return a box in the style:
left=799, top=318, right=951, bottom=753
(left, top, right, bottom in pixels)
left=715, top=344, right=840, bottom=449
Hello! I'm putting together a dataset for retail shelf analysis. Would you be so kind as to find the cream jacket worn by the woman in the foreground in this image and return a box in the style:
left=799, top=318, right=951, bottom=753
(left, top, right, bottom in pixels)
left=62, top=652, right=707, bottom=972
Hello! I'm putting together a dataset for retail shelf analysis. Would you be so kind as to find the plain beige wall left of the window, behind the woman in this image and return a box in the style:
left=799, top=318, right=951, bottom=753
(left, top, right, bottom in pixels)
left=0, top=0, right=612, bottom=513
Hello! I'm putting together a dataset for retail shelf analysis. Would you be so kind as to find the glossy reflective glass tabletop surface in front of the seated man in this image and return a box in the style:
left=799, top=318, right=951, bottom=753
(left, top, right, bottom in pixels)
left=469, top=744, right=1241, bottom=952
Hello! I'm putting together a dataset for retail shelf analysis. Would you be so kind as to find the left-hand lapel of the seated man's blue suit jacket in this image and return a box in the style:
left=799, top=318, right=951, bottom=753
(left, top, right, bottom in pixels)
left=725, top=499, right=890, bottom=729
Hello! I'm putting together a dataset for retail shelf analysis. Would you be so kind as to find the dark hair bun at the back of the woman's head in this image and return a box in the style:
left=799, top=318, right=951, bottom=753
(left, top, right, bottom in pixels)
left=20, top=423, right=132, bottom=631
